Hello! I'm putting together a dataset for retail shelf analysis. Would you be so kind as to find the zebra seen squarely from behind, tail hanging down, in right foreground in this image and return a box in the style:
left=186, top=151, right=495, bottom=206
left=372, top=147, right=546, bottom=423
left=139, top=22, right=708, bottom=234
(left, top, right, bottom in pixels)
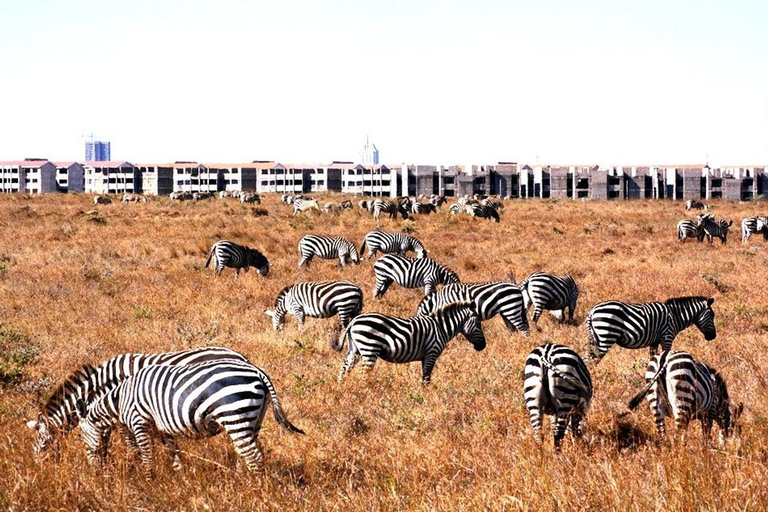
left=523, top=343, right=592, bottom=449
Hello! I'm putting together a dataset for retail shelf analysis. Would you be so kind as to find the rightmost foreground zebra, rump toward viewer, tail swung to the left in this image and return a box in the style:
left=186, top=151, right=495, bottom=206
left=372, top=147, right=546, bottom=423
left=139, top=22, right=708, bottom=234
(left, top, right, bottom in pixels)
left=629, top=350, right=744, bottom=443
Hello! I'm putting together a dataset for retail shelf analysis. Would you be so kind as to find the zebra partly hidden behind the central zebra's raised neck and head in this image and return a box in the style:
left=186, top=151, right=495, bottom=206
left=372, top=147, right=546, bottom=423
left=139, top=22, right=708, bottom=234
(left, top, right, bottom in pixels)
left=417, top=281, right=530, bottom=336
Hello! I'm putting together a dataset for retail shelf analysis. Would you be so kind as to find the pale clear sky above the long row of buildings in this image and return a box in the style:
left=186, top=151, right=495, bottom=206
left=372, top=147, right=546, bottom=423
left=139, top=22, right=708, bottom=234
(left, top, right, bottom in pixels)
left=0, top=0, right=768, bottom=165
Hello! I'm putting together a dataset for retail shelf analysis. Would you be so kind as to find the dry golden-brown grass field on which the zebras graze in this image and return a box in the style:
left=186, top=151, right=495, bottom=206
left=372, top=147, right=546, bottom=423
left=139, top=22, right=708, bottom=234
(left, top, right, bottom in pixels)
left=0, top=195, right=768, bottom=510
